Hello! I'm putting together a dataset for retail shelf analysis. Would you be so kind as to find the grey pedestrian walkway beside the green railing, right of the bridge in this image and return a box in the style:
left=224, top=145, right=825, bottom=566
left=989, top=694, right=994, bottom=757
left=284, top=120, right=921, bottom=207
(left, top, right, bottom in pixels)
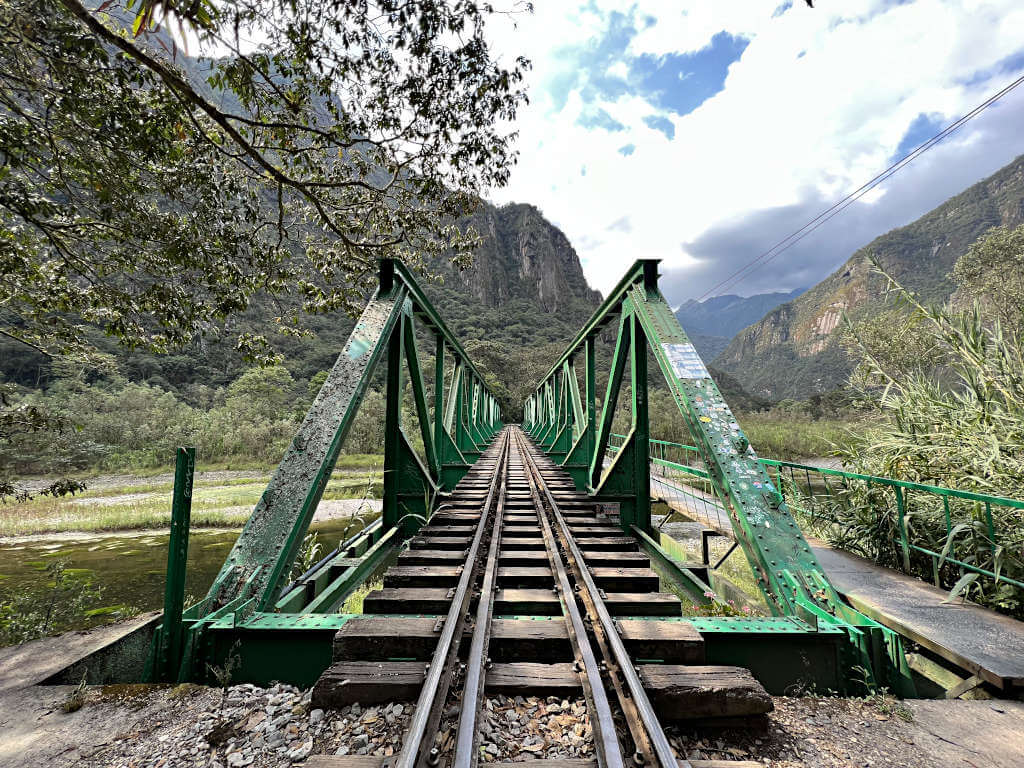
left=651, top=475, right=1024, bottom=688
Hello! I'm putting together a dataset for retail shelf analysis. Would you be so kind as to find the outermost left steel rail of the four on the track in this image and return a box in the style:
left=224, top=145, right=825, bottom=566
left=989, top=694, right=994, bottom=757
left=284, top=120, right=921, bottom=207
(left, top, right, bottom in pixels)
left=393, top=428, right=511, bottom=768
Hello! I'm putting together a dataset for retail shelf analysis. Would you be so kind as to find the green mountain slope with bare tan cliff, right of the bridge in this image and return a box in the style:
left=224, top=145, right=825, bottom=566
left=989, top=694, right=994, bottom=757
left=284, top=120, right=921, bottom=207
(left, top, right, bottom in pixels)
left=712, top=156, right=1024, bottom=399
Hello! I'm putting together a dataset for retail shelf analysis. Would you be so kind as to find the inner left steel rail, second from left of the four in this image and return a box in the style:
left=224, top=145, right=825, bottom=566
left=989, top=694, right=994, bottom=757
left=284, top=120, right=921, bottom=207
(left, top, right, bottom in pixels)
left=454, top=434, right=511, bottom=768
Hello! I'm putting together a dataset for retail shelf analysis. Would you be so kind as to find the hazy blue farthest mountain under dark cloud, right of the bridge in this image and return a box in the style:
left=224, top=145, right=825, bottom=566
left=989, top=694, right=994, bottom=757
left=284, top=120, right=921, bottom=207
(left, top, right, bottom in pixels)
left=676, top=288, right=807, bottom=360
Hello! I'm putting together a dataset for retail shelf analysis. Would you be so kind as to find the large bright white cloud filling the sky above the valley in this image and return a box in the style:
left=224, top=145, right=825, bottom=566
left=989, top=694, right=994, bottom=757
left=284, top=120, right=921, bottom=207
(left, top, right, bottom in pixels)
left=483, top=0, right=1024, bottom=298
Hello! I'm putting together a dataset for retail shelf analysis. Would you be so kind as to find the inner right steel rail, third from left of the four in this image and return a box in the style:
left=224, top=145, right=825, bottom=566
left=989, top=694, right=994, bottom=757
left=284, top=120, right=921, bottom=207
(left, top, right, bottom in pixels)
left=515, top=431, right=625, bottom=768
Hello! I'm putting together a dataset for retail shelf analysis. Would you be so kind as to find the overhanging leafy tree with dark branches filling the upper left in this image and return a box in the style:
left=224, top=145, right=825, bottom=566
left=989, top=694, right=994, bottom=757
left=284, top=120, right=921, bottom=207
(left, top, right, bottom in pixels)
left=0, top=0, right=526, bottom=358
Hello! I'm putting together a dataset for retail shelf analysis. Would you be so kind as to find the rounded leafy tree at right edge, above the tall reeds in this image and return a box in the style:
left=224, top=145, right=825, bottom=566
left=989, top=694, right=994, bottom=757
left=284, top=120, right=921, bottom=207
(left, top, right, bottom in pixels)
left=953, top=224, right=1024, bottom=334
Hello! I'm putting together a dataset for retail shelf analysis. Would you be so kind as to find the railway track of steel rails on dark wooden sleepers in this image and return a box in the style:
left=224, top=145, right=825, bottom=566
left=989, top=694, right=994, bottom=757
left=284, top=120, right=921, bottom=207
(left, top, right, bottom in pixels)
left=313, top=427, right=772, bottom=768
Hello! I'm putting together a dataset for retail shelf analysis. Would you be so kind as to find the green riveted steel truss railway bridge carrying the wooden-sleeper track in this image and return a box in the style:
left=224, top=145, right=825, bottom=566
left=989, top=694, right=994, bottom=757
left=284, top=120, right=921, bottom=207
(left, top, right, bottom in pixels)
left=51, top=260, right=1024, bottom=768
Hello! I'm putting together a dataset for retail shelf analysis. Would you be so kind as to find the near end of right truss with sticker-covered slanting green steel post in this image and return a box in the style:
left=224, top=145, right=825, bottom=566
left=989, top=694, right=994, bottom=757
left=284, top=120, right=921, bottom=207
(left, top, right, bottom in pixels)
left=530, top=260, right=913, bottom=694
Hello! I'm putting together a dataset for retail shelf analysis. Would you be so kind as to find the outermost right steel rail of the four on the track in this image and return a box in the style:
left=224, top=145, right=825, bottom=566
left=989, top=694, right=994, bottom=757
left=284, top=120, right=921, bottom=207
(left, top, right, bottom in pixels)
left=517, top=435, right=690, bottom=768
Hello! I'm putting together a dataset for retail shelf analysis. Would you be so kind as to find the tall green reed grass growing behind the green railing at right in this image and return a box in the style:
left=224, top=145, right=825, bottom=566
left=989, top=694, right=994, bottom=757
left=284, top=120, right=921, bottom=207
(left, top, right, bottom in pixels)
left=828, top=272, right=1024, bottom=614
